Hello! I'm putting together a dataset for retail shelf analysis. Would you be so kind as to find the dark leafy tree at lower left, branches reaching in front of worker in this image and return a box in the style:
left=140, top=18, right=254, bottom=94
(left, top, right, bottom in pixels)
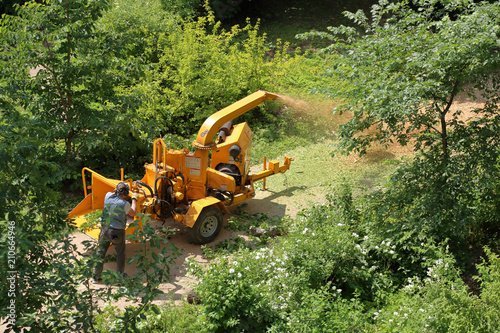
left=0, top=104, right=177, bottom=332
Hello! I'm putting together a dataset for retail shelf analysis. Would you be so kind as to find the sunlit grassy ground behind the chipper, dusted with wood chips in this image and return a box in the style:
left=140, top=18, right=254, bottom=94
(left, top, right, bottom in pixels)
left=250, top=92, right=411, bottom=216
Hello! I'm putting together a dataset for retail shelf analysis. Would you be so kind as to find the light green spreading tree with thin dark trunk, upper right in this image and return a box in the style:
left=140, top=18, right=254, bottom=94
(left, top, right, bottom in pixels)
left=299, top=0, right=500, bottom=160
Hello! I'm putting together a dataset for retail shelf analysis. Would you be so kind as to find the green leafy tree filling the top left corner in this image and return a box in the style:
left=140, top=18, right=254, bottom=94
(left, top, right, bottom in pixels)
left=0, top=0, right=139, bottom=163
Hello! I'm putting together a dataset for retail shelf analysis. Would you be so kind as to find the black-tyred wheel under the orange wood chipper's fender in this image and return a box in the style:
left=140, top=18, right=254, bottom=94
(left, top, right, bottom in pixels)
left=191, top=206, right=223, bottom=244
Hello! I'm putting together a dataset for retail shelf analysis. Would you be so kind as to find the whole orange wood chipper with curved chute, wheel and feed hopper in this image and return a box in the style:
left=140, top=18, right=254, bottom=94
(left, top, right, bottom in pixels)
left=69, top=91, right=292, bottom=244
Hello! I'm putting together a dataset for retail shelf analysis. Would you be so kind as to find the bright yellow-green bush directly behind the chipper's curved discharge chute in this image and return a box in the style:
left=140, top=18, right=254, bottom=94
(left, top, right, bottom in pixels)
left=136, top=10, right=296, bottom=137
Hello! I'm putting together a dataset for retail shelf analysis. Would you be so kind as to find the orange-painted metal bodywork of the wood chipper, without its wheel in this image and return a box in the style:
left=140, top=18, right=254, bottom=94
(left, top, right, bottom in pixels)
left=68, top=91, right=293, bottom=238
